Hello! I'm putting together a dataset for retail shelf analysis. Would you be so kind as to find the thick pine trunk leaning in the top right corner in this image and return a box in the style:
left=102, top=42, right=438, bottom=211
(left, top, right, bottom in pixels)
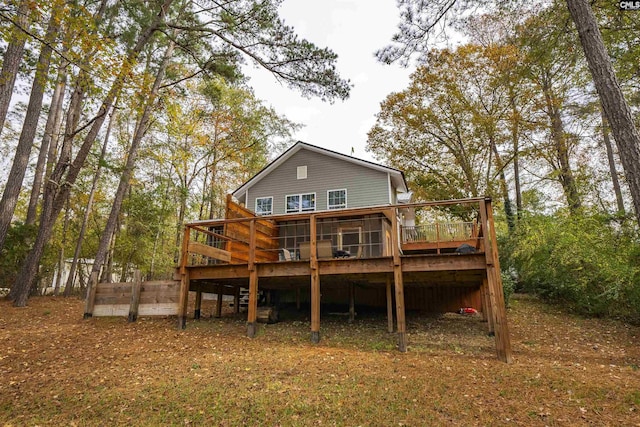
left=566, top=0, right=640, bottom=224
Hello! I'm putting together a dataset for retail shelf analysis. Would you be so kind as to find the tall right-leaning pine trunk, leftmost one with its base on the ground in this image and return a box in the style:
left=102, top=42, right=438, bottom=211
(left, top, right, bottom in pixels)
left=14, top=0, right=173, bottom=307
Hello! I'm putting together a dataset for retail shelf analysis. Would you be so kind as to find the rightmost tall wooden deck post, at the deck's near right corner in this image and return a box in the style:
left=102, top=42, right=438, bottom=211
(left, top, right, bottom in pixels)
left=480, top=199, right=511, bottom=363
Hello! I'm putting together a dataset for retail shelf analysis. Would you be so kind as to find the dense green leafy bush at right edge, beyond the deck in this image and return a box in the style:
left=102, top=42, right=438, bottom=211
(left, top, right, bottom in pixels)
left=505, top=214, right=640, bottom=321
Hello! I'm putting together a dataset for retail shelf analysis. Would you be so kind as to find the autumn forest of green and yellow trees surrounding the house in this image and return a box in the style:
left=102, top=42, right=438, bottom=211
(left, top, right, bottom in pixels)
left=0, top=0, right=640, bottom=322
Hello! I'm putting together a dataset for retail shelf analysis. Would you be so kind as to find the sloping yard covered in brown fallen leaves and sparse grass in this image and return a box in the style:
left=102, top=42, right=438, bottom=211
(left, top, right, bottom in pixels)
left=0, top=296, right=640, bottom=426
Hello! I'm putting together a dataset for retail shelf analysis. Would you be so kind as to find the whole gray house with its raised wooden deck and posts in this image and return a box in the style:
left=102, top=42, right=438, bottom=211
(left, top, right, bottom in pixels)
left=85, top=142, right=511, bottom=362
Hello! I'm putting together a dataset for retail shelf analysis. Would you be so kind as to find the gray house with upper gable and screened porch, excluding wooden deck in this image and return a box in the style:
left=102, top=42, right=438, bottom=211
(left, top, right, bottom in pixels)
left=233, top=142, right=411, bottom=259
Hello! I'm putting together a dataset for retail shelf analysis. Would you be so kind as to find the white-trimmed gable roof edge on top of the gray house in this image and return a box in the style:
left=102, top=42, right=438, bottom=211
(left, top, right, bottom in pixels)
left=232, top=141, right=408, bottom=198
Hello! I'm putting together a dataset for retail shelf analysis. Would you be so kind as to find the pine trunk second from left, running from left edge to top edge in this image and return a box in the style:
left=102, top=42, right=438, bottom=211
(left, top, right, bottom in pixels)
left=0, top=1, right=61, bottom=250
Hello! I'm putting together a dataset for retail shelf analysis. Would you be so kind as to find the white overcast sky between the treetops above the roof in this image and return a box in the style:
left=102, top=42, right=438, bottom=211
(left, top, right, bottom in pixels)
left=246, top=0, right=410, bottom=160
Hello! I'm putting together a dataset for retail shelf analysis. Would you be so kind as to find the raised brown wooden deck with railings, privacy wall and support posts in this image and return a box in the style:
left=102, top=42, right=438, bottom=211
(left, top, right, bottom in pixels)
left=174, top=198, right=511, bottom=362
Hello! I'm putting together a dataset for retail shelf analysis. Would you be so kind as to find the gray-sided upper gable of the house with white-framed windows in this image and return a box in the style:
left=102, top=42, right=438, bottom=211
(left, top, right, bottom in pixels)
left=233, top=142, right=408, bottom=215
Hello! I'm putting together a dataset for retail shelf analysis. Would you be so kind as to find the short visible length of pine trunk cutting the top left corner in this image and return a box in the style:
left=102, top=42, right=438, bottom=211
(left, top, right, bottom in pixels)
left=0, top=0, right=30, bottom=138
